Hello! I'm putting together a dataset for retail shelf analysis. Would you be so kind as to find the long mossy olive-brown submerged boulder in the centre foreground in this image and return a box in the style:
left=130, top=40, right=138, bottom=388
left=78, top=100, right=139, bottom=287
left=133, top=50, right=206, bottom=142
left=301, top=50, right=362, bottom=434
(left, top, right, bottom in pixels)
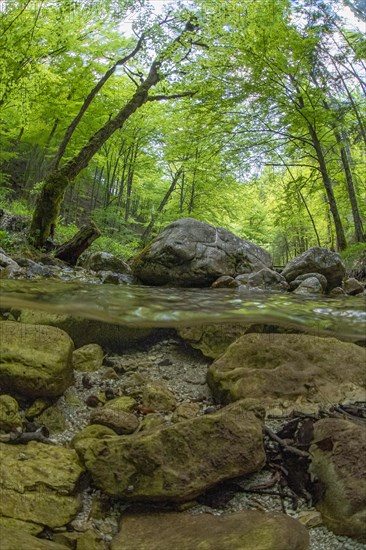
left=81, top=402, right=265, bottom=502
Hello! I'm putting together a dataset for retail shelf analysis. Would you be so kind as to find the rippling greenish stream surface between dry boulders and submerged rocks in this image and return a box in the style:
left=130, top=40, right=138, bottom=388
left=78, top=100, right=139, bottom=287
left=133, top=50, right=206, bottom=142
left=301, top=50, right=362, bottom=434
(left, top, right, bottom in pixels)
left=0, top=280, right=366, bottom=342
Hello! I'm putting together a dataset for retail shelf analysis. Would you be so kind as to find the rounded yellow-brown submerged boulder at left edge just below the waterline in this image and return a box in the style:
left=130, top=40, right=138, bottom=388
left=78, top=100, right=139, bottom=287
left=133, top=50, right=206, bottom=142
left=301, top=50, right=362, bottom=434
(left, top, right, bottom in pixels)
left=0, top=321, right=74, bottom=397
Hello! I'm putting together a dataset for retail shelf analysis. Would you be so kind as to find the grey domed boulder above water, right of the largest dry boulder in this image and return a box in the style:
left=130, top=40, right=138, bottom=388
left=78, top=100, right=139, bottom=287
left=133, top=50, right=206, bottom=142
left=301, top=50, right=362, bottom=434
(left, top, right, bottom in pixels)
left=282, top=246, right=346, bottom=290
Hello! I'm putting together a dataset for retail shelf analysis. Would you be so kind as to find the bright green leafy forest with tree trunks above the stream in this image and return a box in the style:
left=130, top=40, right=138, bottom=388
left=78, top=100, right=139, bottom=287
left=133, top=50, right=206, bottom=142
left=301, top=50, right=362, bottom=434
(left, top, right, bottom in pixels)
left=0, top=0, right=366, bottom=265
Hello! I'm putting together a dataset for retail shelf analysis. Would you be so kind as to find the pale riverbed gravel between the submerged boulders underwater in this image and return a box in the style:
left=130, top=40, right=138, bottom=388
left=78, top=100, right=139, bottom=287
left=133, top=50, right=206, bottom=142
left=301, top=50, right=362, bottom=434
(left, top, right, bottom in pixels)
left=52, top=336, right=366, bottom=550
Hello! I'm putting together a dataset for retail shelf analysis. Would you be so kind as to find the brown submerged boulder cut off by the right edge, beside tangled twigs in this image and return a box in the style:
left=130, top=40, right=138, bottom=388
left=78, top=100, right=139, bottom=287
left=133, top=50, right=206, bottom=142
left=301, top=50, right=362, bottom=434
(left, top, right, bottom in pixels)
left=310, top=418, right=366, bottom=542
